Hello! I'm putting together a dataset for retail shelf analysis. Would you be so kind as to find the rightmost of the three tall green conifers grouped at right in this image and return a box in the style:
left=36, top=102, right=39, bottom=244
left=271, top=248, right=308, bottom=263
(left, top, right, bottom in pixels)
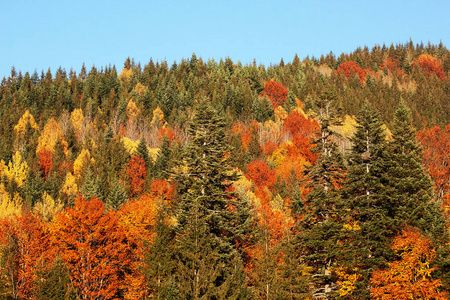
left=387, top=100, right=446, bottom=241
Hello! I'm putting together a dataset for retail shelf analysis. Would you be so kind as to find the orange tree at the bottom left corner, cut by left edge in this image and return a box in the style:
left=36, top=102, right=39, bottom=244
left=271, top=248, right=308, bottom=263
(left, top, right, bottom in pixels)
left=0, top=212, right=55, bottom=299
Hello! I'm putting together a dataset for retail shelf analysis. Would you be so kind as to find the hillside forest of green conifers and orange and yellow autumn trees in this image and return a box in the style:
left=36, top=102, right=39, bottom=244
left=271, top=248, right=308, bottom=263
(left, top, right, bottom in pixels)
left=0, top=41, right=450, bottom=300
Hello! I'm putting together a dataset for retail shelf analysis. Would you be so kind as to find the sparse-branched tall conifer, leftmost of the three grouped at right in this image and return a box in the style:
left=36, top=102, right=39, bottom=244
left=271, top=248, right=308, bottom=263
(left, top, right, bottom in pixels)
left=294, top=93, right=345, bottom=297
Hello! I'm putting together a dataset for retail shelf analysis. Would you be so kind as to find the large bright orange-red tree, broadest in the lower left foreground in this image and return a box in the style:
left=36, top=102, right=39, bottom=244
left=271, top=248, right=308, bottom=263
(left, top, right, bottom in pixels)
left=54, top=197, right=144, bottom=299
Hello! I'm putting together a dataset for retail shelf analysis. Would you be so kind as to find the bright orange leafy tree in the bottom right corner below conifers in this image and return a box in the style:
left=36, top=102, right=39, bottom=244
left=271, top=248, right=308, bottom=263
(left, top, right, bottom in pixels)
left=370, top=228, right=447, bottom=300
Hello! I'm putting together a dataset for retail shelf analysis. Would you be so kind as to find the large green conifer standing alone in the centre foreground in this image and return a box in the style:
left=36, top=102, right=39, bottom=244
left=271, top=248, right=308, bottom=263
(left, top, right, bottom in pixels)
left=173, top=100, right=249, bottom=299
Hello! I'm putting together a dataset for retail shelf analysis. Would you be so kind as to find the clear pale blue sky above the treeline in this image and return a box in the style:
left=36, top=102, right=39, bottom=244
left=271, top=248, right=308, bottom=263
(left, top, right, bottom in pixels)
left=0, top=0, right=450, bottom=79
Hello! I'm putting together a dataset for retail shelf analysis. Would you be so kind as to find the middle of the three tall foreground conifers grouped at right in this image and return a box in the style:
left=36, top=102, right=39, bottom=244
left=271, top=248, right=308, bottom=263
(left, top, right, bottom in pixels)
left=340, top=103, right=396, bottom=299
